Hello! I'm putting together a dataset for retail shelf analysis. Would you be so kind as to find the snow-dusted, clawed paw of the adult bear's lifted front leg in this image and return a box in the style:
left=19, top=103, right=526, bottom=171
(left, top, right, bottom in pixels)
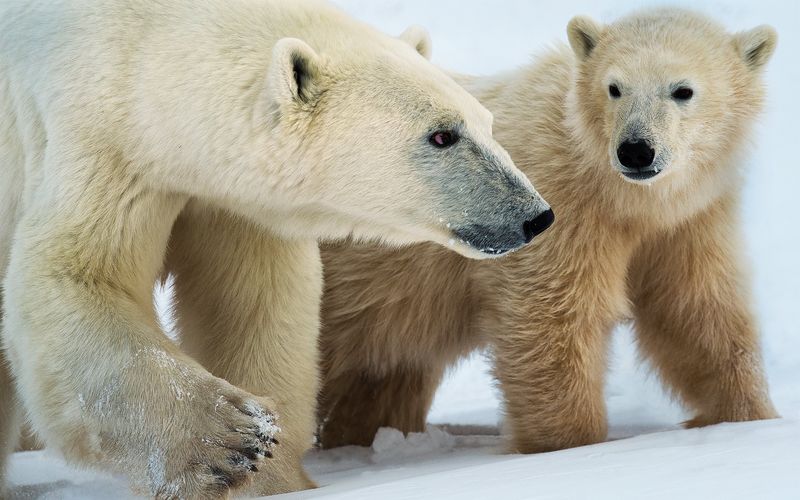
left=152, top=388, right=280, bottom=499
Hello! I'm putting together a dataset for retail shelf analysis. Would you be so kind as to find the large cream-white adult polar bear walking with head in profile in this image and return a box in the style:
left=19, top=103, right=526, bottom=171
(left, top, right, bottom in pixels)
left=0, top=0, right=552, bottom=498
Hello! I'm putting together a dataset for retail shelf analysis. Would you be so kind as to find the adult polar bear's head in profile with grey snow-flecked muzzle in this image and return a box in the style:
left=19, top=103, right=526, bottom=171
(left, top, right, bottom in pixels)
left=258, top=28, right=553, bottom=258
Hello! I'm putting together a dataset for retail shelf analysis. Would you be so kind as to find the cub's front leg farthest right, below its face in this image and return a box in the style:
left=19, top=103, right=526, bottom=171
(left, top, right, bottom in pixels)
left=631, top=195, right=777, bottom=426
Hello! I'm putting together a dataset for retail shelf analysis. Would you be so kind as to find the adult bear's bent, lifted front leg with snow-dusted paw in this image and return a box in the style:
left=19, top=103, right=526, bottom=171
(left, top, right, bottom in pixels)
left=4, top=154, right=276, bottom=498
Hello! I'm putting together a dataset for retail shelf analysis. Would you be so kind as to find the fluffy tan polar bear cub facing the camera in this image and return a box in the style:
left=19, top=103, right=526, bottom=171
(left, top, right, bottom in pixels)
left=320, top=7, right=775, bottom=452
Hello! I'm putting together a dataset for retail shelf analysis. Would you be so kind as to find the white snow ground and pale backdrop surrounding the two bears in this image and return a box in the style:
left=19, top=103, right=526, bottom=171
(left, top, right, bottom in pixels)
left=3, top=0, right=800, bottom=499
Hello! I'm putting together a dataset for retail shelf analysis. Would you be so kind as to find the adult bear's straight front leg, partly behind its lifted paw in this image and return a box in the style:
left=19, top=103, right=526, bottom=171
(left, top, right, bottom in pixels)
left=167, top=203, right=322, bottom=495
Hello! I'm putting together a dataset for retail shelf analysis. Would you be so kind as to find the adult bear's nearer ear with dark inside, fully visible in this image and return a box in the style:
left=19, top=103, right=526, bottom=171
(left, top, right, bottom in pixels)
left=267, top=38, right=320, bottom=104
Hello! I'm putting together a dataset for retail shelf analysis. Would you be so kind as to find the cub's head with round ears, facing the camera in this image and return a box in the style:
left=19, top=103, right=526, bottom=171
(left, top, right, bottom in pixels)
left=568, top=10, right=776, bottom=189
